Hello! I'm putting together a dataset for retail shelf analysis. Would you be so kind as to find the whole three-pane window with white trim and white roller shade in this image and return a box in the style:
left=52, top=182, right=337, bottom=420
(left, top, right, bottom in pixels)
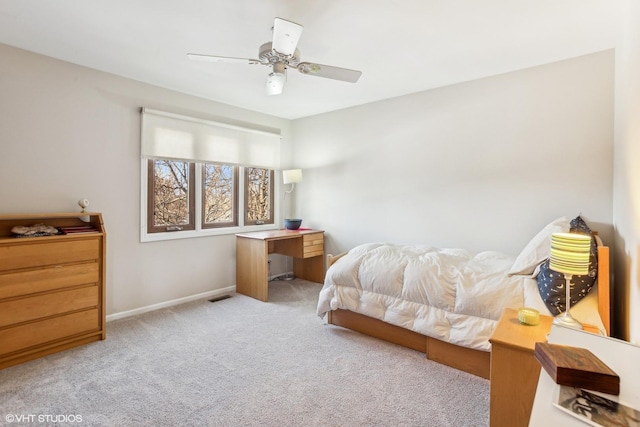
left=140, top=108, right=280, bottom=241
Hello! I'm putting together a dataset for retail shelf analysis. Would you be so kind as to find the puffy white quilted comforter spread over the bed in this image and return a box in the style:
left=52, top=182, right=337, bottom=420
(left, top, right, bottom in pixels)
left=318, top=243, right=548, bottom=351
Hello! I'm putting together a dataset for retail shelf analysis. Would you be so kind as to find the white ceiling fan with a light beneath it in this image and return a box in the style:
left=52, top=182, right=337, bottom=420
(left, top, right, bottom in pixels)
left=187, top=18, right=362, bottom=95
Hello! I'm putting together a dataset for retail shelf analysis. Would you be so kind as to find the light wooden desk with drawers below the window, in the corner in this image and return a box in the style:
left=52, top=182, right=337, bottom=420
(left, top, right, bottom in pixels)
left=236, top=230, right=324, bottom=302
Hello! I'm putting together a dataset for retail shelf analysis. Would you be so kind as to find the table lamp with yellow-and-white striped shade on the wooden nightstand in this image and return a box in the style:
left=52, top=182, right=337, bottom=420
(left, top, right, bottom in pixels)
left=549, top=233, right=591, bottom=329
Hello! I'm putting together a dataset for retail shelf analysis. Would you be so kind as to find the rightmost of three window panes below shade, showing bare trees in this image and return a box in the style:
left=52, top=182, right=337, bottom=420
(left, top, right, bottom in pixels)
left=245, top=167, right=274, bottom=224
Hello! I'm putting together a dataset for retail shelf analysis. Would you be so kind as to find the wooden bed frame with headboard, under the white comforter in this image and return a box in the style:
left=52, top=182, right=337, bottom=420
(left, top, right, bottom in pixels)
left=327, top=239, right=611, bottom=379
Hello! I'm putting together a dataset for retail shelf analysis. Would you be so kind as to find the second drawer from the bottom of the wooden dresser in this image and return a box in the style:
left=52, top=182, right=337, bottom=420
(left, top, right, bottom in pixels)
left=0, top=285, right=99, bottom=328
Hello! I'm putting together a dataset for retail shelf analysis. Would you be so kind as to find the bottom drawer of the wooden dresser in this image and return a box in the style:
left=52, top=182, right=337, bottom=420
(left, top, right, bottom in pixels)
left=0, top=309, right=100, bottom=356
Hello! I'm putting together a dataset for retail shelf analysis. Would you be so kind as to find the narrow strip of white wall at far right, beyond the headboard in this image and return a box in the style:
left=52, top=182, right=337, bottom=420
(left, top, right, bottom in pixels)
left=613, top=1, right=640, bottom=345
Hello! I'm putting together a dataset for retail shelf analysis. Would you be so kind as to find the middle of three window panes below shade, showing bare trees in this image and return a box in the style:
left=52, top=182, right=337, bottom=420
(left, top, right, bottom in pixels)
left=202, top=163, right=238, bottom=228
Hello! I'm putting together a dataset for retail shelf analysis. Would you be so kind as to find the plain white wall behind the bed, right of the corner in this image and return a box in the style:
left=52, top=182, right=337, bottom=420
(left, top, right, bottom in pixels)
left=292, top=51, right=614, bottom=255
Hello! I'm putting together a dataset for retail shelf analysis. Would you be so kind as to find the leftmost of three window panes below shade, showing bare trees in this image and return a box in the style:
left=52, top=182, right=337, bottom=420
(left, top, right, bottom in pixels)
left=148, top=160, right=194, bottom=231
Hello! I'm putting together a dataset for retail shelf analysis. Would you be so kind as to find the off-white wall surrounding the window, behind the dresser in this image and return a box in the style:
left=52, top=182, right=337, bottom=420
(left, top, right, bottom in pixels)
left=0, top=45, right=290, bottom=314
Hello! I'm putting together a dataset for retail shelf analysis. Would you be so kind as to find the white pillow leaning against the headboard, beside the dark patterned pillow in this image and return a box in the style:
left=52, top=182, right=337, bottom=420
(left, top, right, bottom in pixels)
left=508, top=216, right=571, bottom=276
